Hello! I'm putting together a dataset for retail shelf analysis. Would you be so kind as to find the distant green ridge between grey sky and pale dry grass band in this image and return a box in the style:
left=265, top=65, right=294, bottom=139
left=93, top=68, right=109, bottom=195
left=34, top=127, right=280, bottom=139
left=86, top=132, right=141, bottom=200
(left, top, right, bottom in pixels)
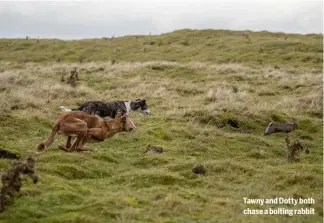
left=0, top=29, right=323, bottom=71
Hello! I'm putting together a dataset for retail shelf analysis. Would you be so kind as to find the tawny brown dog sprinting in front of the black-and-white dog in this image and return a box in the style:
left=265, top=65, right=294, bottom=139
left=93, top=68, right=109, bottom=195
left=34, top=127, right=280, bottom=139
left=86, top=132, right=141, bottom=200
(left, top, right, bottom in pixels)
left=36, top=111, right=135, bottom=153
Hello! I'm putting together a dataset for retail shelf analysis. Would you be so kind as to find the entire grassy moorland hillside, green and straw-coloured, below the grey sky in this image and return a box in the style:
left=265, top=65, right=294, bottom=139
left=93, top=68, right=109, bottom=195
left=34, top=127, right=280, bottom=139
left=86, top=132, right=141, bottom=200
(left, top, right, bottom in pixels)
left=0, top=30, right=323, bottom=223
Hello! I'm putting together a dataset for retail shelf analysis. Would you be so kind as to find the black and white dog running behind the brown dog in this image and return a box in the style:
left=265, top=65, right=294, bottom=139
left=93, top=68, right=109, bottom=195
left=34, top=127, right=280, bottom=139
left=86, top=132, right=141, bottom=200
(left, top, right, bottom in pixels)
left=60, top=99, right=151, bottom=119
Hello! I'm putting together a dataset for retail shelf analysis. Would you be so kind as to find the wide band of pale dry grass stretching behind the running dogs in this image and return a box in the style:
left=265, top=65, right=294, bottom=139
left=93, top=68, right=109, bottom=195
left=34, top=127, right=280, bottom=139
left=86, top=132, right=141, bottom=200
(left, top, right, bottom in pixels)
left=0, top=61, right=323, bottom=121
